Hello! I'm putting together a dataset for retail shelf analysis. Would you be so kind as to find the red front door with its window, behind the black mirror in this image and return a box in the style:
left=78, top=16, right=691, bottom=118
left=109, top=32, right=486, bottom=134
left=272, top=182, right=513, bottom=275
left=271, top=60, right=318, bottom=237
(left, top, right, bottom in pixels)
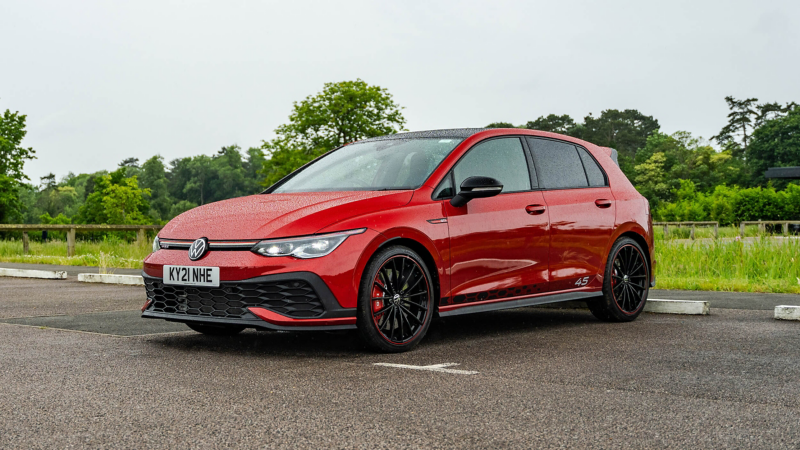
left=442, top=137, right=550, bottom=305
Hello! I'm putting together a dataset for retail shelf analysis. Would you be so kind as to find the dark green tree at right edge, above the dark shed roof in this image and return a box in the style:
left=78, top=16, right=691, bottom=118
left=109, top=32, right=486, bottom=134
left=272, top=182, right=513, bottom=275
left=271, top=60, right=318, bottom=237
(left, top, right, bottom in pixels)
left=746, top=108, right=800, bottom=186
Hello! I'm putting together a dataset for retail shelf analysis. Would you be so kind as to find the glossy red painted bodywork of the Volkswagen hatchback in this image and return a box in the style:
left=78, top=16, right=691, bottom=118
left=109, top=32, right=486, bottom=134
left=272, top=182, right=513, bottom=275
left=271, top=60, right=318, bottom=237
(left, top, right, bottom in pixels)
left=144, top=129, right=654, bottom=325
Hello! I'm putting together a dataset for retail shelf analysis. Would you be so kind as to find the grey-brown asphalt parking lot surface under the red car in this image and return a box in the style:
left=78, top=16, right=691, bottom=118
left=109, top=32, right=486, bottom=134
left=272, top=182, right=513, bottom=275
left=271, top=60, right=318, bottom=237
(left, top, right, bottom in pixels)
left=0, top=272, right=800, bottom=448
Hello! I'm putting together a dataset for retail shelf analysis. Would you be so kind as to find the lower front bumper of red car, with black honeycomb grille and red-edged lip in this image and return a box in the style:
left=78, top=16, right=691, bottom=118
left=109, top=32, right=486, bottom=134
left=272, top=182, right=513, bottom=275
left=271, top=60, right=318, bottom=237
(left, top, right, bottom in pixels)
left=142, top=272, right=356, bottom=330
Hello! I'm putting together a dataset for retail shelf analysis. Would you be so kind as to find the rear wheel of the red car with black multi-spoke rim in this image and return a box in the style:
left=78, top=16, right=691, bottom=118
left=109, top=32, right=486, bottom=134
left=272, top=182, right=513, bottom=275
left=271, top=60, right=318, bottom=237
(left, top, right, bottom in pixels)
left=588, top=237, right=650, bottom=322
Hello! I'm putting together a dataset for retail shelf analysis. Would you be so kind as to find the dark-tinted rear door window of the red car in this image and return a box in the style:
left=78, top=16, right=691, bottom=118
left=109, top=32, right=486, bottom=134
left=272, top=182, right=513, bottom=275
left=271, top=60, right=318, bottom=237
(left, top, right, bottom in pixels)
left=528, top=138, right=589, bottom=189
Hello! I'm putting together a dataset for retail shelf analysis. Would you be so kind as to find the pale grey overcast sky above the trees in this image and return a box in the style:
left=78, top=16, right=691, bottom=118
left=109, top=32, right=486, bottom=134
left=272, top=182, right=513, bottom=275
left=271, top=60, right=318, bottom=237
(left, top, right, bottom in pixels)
left=0, top=0, right=800, bottom=183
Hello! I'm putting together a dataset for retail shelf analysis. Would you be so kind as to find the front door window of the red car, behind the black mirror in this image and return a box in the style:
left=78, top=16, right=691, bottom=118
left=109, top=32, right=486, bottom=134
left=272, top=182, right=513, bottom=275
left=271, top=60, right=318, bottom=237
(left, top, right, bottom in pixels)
left=453, top=137, right=531, bottom=192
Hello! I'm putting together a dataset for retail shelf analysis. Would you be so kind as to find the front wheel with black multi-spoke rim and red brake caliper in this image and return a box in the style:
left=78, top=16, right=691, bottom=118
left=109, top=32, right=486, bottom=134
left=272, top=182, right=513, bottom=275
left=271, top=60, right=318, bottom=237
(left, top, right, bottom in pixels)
left=356, top=245, right=435, bottom=353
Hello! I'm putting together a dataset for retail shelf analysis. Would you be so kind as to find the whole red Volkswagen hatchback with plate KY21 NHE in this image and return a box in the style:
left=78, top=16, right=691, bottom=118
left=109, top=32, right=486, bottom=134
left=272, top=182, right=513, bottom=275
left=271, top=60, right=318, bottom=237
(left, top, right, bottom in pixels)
left=142, top=129, right=655, bottom=352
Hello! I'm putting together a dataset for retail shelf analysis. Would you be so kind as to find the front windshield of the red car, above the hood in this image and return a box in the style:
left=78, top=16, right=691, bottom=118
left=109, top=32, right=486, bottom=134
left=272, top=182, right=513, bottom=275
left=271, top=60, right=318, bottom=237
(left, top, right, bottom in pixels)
left=273, top=139, right=461, bottom=193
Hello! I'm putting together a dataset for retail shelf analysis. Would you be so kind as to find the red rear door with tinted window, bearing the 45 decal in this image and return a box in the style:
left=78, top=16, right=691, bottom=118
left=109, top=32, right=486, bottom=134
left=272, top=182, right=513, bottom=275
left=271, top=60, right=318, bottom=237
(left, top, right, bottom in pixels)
left=528, top=138, right=616, bottom=291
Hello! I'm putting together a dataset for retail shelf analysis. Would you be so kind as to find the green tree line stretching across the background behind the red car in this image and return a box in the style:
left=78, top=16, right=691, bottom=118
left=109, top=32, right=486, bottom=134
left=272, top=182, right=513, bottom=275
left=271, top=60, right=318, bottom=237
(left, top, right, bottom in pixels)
left=0, top=79, right=800, bottom=229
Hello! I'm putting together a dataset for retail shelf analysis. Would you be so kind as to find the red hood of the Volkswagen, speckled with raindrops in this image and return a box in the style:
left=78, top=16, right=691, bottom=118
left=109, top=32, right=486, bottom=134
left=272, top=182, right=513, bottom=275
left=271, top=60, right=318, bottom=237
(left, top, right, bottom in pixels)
left=159, top=191, right=413, bottom=240
